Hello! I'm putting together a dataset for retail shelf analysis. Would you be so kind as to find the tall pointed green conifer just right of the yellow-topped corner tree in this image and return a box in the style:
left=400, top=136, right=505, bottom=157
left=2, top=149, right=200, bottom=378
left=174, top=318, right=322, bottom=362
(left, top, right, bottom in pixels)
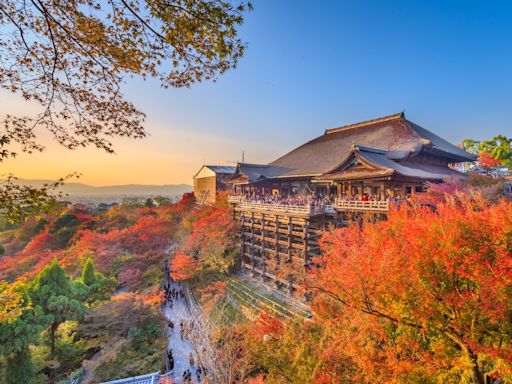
left=30, top=259, right=85, bottom=379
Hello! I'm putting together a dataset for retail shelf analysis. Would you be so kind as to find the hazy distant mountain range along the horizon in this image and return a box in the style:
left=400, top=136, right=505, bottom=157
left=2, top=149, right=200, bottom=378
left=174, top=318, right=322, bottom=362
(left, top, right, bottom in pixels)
left=9, top=179, right=193, bottom=197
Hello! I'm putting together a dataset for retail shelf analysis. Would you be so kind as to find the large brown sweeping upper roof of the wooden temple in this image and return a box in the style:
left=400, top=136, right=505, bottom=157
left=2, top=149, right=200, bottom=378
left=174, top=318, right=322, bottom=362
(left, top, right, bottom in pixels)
left=271, top=113, right=475, bottom=177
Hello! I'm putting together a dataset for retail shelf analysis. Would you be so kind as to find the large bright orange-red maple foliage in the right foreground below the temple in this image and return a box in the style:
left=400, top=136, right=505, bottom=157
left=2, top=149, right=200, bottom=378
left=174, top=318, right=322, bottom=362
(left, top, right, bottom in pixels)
left=308, top=196, right=512, bottom=383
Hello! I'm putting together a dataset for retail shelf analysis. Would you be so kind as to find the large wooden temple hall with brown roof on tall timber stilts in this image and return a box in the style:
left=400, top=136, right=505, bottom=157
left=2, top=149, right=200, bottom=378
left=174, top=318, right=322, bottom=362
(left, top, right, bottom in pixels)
left=196, top=113, right=476, bottom=292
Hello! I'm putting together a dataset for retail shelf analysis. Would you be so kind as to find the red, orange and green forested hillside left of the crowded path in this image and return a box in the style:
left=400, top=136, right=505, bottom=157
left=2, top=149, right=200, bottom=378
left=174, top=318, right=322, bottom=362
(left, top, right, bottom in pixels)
left=0, top=195, right=200, bottom=383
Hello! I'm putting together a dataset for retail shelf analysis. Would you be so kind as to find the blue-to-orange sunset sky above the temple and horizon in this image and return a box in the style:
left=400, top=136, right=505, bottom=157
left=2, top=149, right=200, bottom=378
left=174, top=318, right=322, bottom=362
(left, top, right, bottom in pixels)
left=0, top=0, right=512, bottom=185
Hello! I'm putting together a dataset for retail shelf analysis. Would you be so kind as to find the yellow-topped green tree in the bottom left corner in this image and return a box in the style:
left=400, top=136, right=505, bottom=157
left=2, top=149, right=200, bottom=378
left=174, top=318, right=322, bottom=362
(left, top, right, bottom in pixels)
left=0, top=283, right=43, bottom=384
